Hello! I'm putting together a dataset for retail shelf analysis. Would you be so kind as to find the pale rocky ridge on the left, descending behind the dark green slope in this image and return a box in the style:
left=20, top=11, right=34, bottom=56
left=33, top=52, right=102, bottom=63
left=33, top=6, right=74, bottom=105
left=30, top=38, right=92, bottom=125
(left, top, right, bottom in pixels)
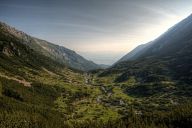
left=0, top=22, right=99, bottom=71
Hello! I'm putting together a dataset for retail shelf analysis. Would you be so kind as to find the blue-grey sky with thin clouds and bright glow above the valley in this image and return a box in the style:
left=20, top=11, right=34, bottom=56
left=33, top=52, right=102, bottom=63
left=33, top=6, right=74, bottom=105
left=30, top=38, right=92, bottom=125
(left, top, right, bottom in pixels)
left=0, top=0, right=192, bottom=65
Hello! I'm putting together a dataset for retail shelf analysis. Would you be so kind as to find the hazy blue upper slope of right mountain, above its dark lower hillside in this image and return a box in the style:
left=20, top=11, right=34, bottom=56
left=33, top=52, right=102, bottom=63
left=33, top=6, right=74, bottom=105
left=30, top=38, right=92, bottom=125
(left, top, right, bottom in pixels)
left=119, top=15, right=192, bottom=62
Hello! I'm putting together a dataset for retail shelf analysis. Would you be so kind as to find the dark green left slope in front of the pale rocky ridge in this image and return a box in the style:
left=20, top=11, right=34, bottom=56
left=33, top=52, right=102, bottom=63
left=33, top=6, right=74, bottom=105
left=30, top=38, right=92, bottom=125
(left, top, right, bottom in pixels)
left=0, top=26, right=65, bottom=74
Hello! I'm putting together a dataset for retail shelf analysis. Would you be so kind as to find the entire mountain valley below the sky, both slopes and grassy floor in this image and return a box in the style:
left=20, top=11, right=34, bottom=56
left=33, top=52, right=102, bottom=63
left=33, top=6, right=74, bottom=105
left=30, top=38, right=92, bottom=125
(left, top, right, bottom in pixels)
left=0, top=13, right=192, bottom=128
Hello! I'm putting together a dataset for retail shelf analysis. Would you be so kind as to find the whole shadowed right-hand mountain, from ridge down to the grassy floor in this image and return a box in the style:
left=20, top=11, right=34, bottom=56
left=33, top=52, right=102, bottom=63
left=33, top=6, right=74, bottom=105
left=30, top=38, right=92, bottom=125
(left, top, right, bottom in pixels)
left=102, top=15, right=192, bottom=83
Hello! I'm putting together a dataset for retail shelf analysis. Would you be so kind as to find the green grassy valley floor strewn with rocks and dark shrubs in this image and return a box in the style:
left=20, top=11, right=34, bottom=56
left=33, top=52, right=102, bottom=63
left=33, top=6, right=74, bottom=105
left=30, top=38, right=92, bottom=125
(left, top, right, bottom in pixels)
left=0, top=67, right=192, bottom=128
